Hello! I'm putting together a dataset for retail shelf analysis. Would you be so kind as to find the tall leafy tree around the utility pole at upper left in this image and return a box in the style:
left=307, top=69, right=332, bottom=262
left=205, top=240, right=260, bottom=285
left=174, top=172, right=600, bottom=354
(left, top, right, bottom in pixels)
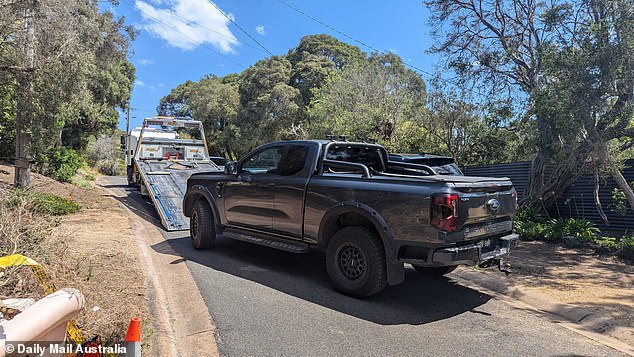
left=0, top=0, right=134, bottom=186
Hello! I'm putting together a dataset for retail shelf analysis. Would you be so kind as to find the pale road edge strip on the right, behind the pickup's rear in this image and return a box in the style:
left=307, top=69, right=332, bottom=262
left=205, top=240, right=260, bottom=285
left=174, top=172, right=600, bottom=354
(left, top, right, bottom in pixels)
left=447, top=268, right=634, bottom=356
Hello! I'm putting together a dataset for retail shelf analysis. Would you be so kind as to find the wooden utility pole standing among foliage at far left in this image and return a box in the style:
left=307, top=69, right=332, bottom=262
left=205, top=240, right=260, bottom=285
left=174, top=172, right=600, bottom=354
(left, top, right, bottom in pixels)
left=14, top=0, right=37, bottom=188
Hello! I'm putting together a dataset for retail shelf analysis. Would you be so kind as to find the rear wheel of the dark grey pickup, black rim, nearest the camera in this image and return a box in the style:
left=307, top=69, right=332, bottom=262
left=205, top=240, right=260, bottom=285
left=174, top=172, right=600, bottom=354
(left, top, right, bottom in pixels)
left=326, top=227, right=387, bottom=297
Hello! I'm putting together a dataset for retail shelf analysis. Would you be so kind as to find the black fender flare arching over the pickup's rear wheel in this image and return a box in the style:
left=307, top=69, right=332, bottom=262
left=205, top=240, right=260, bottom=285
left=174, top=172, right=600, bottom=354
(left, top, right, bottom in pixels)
left=319, top=201, right=405, bottom=285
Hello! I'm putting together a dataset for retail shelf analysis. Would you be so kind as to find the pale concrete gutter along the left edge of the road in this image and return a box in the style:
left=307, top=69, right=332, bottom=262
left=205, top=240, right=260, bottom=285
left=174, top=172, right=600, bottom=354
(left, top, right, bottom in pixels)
left=97, top=180, right=219, bottom=357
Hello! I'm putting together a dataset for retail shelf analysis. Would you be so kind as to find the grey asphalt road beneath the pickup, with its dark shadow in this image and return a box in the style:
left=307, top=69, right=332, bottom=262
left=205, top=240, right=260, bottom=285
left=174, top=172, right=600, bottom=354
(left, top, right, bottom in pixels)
left=100, top=178, right=622, bottom=356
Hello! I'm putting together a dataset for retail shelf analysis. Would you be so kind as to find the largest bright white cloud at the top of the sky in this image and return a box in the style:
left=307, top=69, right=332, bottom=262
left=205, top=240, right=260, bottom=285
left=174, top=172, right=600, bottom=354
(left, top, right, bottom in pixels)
left=135, top=0, right=238, bottom=53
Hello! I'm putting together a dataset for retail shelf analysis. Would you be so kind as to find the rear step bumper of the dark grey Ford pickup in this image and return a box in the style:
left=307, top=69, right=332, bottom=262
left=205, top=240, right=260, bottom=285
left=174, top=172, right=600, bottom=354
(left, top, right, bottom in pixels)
left=431, top=233, right=519, bottom=266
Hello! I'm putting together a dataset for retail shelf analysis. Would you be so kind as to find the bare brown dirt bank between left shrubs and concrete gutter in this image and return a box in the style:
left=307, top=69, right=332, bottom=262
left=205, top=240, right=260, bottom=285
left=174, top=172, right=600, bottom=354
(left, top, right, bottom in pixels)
left=0, top=163, right=150, bottom=341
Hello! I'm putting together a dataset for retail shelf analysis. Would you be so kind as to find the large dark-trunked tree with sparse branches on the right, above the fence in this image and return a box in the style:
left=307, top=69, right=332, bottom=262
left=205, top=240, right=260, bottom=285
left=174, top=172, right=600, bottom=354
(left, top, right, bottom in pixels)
left=426, top=0, right=634, bottom=208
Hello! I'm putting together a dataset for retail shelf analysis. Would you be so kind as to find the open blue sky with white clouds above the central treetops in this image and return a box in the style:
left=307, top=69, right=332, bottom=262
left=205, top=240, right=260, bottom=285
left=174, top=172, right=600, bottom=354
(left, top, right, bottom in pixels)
left=110, top=0, right=437, bottom=128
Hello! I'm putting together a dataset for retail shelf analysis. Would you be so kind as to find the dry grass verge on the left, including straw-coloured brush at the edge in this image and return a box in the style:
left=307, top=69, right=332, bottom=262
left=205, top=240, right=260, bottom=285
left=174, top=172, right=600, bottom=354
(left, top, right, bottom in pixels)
left=0, top=163, right=149, bottom=344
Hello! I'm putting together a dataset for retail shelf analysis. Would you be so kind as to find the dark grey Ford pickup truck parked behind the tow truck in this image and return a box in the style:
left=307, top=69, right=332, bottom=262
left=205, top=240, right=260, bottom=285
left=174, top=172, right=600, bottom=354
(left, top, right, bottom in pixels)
left=183, top=140, right=519, bottom=297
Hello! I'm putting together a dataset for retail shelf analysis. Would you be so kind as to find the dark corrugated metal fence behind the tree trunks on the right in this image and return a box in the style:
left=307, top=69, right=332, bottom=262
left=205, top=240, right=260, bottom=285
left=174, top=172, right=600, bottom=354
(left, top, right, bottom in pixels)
left=463, top=160, right=634, bottom=235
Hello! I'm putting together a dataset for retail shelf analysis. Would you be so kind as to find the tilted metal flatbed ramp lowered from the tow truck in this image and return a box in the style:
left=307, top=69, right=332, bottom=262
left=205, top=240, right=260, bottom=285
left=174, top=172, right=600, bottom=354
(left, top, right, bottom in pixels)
left=136, top=160, right=222, bottom=231
